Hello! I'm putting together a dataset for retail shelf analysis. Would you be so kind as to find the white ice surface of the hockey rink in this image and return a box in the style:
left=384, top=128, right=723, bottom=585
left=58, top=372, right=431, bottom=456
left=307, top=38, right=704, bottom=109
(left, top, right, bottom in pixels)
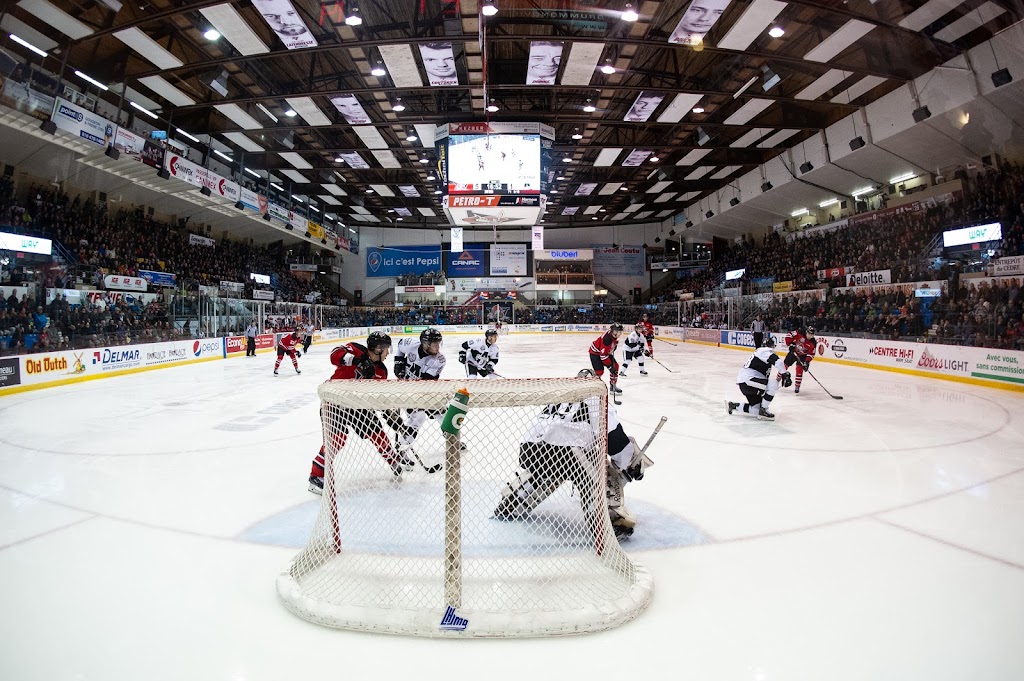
left=0, top=334, right=1024, bottom=681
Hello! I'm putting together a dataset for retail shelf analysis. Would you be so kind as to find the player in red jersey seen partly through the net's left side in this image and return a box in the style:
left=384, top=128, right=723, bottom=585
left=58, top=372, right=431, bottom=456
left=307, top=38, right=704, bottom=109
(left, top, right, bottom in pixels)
left=309, top=331, right=415, bottom=495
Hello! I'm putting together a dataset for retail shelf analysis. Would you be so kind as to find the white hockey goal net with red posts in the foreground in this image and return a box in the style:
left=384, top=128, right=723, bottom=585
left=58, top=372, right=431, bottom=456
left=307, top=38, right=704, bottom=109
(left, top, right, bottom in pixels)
left=278, top=378, right=653, bottom=637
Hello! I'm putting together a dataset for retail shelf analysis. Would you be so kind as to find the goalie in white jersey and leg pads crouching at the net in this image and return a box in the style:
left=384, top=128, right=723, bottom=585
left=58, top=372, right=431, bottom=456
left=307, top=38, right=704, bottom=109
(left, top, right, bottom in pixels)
left=495, top=369, right=652, bottom=539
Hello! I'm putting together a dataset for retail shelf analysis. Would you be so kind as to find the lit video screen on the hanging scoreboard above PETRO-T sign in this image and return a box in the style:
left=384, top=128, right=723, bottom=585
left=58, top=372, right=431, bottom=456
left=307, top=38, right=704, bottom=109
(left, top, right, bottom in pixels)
left=447, top=134, right=541, bottom=194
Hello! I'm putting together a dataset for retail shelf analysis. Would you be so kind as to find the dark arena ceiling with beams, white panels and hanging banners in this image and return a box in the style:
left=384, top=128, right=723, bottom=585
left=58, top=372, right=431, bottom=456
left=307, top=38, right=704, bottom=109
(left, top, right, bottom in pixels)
left=3, top=0, right=1021, bottom=236
